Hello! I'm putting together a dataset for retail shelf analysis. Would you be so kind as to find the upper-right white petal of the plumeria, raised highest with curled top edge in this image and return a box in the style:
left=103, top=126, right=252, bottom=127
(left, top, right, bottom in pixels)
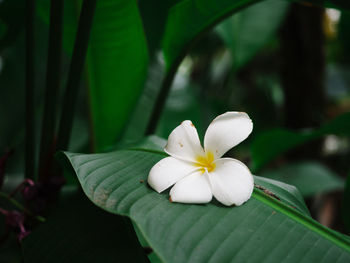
left=204, top=111, right=253, bottom=159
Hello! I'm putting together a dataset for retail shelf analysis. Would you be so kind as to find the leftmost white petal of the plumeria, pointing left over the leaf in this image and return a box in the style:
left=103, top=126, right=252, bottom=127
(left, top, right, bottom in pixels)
left=147, top=157, right=198, bottom=193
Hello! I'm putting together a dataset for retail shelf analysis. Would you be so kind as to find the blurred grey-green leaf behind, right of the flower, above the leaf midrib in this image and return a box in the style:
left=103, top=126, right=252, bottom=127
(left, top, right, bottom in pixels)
left=261, top=162, right=344, bottom=197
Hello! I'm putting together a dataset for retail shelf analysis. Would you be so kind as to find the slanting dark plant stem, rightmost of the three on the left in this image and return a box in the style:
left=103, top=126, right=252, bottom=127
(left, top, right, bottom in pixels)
left=57, top=0, right=96, bottom=150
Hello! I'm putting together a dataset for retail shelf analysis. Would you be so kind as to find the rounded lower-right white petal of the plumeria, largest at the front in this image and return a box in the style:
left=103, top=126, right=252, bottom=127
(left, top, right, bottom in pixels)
left=208, top=158, right=254, bottom=206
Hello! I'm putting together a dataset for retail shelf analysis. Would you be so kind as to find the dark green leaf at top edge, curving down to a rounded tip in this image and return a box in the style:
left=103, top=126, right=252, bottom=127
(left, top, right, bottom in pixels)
left=163, top=0, right=350, bottom=71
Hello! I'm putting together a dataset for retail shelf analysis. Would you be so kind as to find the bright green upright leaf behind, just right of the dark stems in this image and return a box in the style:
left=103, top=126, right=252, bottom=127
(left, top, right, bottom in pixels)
left=38, top=0, right=148, bottom=151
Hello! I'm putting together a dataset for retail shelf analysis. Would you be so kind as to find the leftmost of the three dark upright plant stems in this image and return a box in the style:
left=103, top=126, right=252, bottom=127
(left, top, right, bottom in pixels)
left=25, top=0, right=35, bottom=179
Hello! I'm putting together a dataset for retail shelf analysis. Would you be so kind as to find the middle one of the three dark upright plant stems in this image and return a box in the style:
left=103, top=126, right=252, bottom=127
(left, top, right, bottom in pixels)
left=39, top=0, right=63, bottom=180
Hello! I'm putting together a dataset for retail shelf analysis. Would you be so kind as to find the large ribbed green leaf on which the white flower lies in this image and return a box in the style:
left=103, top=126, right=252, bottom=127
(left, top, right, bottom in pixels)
left=58, top=150, right=350, bottom=262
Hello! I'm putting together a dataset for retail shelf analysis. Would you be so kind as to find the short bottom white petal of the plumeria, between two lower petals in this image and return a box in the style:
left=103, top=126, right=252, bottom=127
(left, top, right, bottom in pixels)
left=170, top=172, right=212, bottom=204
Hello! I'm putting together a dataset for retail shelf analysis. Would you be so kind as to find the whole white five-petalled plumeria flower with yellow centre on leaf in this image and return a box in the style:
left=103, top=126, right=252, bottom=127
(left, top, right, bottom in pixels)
left=148, top=112, right=254, bottom=206
